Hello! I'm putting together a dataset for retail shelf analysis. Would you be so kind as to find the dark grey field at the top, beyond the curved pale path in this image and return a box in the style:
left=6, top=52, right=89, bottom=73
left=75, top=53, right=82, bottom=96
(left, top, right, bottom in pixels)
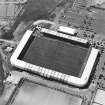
left=21, top=0, right=57, bottom=21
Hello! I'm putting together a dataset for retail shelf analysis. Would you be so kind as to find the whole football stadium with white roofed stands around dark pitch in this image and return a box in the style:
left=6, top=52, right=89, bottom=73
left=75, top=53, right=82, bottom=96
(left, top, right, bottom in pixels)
left=11, top=21, right=99, bottom=87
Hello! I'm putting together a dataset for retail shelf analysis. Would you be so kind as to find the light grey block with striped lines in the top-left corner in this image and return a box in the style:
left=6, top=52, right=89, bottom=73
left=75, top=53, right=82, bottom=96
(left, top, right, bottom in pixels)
left=0, top=0, right=27, bottom=26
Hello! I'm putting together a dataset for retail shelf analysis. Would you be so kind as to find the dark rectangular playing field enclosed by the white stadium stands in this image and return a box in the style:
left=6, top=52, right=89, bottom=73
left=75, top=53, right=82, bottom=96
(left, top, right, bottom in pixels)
left=22, top=34, right=88, bottom=76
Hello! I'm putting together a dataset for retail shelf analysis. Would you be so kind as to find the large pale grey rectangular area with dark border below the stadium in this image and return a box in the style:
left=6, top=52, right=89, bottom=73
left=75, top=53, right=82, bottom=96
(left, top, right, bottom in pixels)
left=8, top=79, right=82, bottom=105
